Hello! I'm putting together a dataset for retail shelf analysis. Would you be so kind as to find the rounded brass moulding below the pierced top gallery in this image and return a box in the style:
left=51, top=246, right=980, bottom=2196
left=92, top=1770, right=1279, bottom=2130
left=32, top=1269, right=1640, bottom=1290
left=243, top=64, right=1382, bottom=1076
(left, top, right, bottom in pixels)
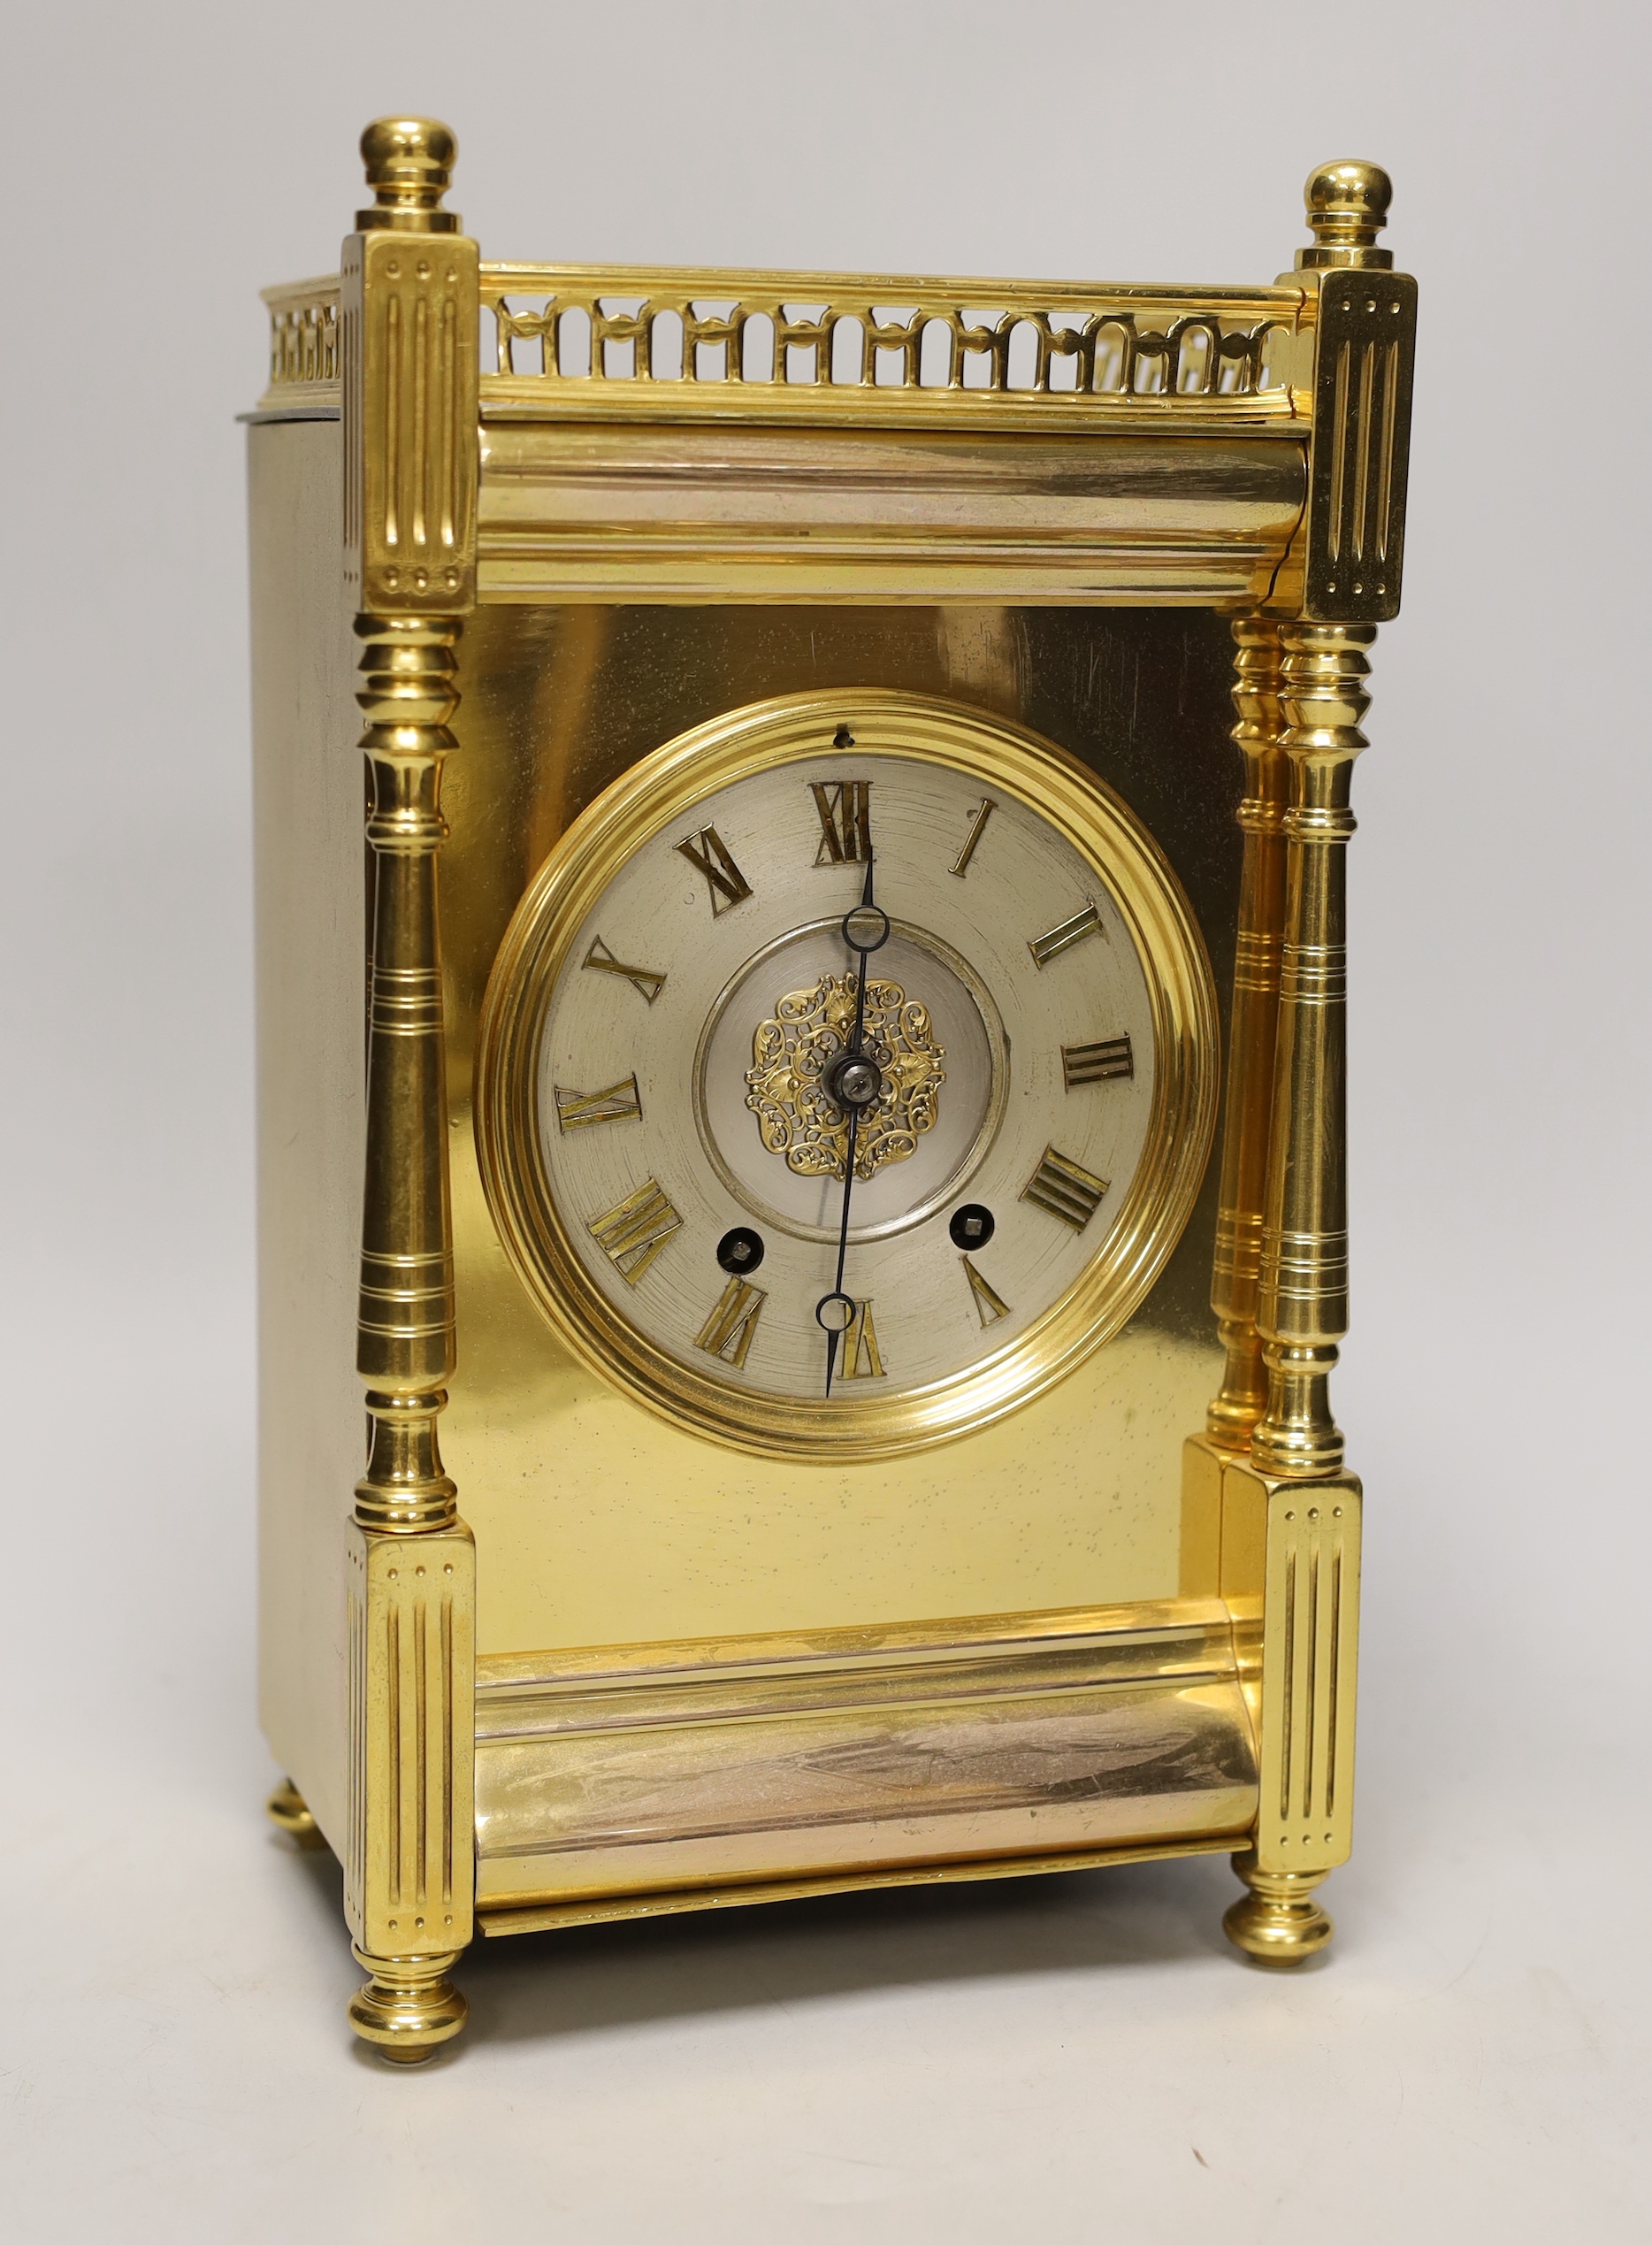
left=478, top=422, right=1306, bottom=606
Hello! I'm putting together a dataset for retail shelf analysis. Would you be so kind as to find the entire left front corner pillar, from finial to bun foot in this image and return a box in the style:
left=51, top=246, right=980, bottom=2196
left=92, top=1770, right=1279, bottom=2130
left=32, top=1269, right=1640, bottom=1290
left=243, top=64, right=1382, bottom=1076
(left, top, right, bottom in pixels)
left=341, top=119, right=478, bottom=2063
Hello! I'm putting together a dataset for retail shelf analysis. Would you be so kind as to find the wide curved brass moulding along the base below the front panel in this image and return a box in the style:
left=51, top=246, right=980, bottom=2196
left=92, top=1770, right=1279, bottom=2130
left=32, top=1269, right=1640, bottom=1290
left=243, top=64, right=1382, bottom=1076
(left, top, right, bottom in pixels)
left=476, top=1598, right=1257, bottom=1911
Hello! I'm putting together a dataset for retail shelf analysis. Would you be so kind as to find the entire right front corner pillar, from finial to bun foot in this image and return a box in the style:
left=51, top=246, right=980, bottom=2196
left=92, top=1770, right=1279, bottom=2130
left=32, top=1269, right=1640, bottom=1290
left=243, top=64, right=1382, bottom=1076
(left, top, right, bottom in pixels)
left=1210, top=164, right=1417, bottom=1965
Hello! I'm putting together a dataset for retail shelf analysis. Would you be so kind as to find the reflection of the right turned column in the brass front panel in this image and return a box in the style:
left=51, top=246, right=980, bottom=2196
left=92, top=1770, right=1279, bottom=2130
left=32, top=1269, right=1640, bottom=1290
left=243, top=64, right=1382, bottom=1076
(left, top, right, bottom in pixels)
left=1205, top=615, right=1289, bottom=1452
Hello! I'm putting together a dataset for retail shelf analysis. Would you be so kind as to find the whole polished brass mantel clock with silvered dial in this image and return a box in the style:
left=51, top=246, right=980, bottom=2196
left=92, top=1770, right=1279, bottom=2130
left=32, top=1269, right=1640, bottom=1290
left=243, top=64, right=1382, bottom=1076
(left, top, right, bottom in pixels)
left=251, top=119, right=1417, bottom=2063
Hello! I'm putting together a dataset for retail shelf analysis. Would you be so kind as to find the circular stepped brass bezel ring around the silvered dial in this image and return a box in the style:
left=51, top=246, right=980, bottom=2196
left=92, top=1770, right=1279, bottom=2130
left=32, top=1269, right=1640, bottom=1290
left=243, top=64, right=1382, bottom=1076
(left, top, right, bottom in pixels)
left=476, top=687, right=1219, bottom=1461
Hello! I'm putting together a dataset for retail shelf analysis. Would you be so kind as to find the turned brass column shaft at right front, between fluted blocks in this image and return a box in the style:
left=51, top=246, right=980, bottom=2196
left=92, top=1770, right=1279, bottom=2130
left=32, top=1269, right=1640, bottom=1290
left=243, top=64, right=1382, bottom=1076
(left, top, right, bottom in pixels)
left=1250, top=622, right=1376, bottom=1480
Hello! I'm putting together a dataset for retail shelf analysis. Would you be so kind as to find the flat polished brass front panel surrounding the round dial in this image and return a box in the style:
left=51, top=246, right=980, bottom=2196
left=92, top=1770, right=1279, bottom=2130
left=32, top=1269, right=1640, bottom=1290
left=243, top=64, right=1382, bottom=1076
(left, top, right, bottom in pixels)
left=442, top=601, right=1243, bottom=1655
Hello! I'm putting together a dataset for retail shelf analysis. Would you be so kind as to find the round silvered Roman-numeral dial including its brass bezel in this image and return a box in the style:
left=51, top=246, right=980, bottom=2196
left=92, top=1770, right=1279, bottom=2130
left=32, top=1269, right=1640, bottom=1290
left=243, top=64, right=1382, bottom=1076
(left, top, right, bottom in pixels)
left=478, top=689, right=1217, bottom=1457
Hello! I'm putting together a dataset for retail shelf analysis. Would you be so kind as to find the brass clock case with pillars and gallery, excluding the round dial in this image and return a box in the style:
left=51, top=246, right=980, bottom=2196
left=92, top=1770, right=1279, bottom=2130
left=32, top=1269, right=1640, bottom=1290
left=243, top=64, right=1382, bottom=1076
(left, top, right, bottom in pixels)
left=247, top=119, right=1417, bottom=2063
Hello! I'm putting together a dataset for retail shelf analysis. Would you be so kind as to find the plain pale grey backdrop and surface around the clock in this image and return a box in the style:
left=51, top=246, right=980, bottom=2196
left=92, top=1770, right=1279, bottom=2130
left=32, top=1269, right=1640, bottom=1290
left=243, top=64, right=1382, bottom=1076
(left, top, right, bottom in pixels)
left=0, top=0, right=1652, bottom=2245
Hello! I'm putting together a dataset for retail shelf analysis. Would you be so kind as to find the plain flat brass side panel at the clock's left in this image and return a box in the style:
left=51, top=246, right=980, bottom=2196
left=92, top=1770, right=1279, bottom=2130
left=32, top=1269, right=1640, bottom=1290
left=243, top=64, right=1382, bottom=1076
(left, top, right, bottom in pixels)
left=247, top=418, right=366, bottom=1850
